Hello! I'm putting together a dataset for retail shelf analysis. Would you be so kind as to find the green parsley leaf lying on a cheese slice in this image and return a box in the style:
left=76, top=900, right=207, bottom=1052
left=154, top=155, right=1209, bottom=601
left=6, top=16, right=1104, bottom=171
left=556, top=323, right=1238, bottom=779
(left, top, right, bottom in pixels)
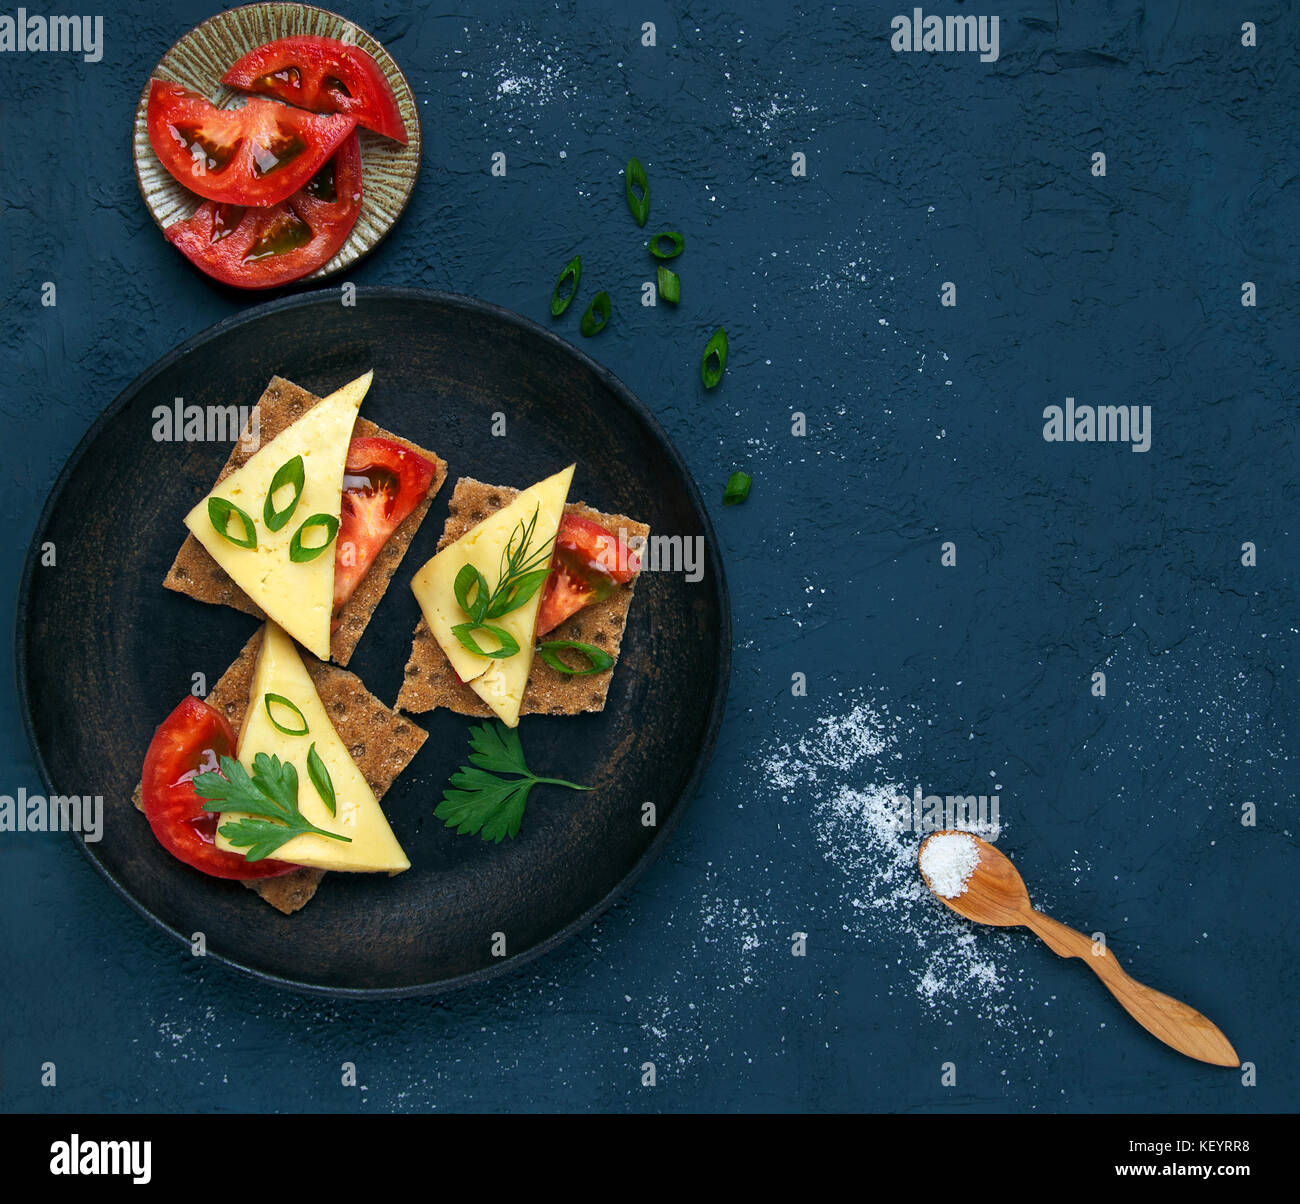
left=192, top=753, right=352, bottom=861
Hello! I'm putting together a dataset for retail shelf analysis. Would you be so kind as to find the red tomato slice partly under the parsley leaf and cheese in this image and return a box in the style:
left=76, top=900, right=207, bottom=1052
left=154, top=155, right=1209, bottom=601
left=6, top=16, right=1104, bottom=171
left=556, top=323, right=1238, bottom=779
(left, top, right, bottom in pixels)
left=140, top=697, right=298, bottom=879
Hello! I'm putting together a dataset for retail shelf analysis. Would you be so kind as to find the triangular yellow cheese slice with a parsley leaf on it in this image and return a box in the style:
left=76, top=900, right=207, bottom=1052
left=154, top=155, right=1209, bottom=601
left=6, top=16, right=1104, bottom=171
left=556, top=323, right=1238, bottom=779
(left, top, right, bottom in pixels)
left=217, top=623, right=411, bottom=874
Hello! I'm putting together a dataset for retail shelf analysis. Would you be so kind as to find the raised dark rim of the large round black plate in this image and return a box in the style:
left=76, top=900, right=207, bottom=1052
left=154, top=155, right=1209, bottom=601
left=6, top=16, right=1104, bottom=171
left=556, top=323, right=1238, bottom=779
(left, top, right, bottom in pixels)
left=14, top=285, right=732, bottom=1000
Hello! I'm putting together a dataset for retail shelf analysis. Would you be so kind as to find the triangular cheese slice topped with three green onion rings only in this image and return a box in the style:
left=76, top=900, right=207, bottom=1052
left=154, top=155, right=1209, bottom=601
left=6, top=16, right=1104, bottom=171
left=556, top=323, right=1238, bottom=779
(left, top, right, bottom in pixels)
left=185, top=372, right=373, bottom=661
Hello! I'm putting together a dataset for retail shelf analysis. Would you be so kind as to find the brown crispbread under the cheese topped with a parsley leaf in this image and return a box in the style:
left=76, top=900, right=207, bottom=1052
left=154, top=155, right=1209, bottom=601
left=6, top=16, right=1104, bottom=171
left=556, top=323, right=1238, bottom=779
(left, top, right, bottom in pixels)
left=131, top=629, right=428, bottom=915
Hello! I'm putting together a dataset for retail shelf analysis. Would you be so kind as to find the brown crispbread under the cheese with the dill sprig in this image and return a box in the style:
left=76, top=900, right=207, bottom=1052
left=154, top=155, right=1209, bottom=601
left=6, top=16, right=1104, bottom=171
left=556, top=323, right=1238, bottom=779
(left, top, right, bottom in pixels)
left=397, top=477, right=650, bottom=715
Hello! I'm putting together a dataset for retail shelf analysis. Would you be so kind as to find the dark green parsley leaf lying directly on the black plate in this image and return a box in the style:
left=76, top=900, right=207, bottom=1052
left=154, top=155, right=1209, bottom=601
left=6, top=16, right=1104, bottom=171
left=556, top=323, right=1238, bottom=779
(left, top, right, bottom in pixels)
left=433, top=720, right=592, bottom=844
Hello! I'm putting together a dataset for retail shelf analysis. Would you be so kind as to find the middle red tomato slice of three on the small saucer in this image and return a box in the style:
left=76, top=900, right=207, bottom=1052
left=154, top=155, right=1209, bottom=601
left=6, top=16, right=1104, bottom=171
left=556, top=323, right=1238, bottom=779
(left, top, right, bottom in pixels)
left=148, top=79, right=356, bottom=205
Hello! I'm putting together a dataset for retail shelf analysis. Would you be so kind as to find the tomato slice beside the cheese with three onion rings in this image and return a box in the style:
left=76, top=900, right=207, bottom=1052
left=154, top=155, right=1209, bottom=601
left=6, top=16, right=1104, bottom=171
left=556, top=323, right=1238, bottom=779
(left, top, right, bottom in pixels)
left=334, top=436, right=434, bottom=612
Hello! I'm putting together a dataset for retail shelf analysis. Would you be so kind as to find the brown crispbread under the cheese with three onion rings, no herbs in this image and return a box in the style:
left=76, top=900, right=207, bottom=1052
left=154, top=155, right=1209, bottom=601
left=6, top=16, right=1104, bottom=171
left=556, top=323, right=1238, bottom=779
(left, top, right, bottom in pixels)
left=163, top=376, right=447, bottom=664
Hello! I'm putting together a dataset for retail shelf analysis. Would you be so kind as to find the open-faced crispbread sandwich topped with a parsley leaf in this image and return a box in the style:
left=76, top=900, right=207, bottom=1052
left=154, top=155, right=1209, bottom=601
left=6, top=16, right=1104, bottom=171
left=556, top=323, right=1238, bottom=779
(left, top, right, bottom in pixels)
left=134, top=623, right=425, bottom=914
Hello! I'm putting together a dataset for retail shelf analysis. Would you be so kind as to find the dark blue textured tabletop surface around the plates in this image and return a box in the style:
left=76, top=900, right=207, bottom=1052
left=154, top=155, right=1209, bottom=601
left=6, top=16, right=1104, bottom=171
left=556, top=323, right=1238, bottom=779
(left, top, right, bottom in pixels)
left=0, top=0, right=1300, bottom=1112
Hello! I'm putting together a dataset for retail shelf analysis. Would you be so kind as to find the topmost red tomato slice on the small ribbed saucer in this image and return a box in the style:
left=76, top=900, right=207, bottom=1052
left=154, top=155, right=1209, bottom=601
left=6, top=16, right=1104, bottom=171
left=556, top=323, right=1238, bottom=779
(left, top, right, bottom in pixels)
left=221, top=35, right=407, bottom=146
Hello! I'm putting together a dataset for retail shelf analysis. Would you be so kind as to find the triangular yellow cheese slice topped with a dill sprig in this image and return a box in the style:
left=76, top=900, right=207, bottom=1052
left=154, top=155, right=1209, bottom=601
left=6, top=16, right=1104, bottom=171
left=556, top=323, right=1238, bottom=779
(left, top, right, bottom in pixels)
left=411, top=464, right=575, bottom=727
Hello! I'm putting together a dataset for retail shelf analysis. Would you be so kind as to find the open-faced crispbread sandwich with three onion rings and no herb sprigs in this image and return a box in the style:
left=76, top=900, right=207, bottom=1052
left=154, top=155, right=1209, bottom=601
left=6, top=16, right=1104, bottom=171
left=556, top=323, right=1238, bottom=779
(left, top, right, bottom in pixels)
left=163, top=373, right=447, bottom=664
